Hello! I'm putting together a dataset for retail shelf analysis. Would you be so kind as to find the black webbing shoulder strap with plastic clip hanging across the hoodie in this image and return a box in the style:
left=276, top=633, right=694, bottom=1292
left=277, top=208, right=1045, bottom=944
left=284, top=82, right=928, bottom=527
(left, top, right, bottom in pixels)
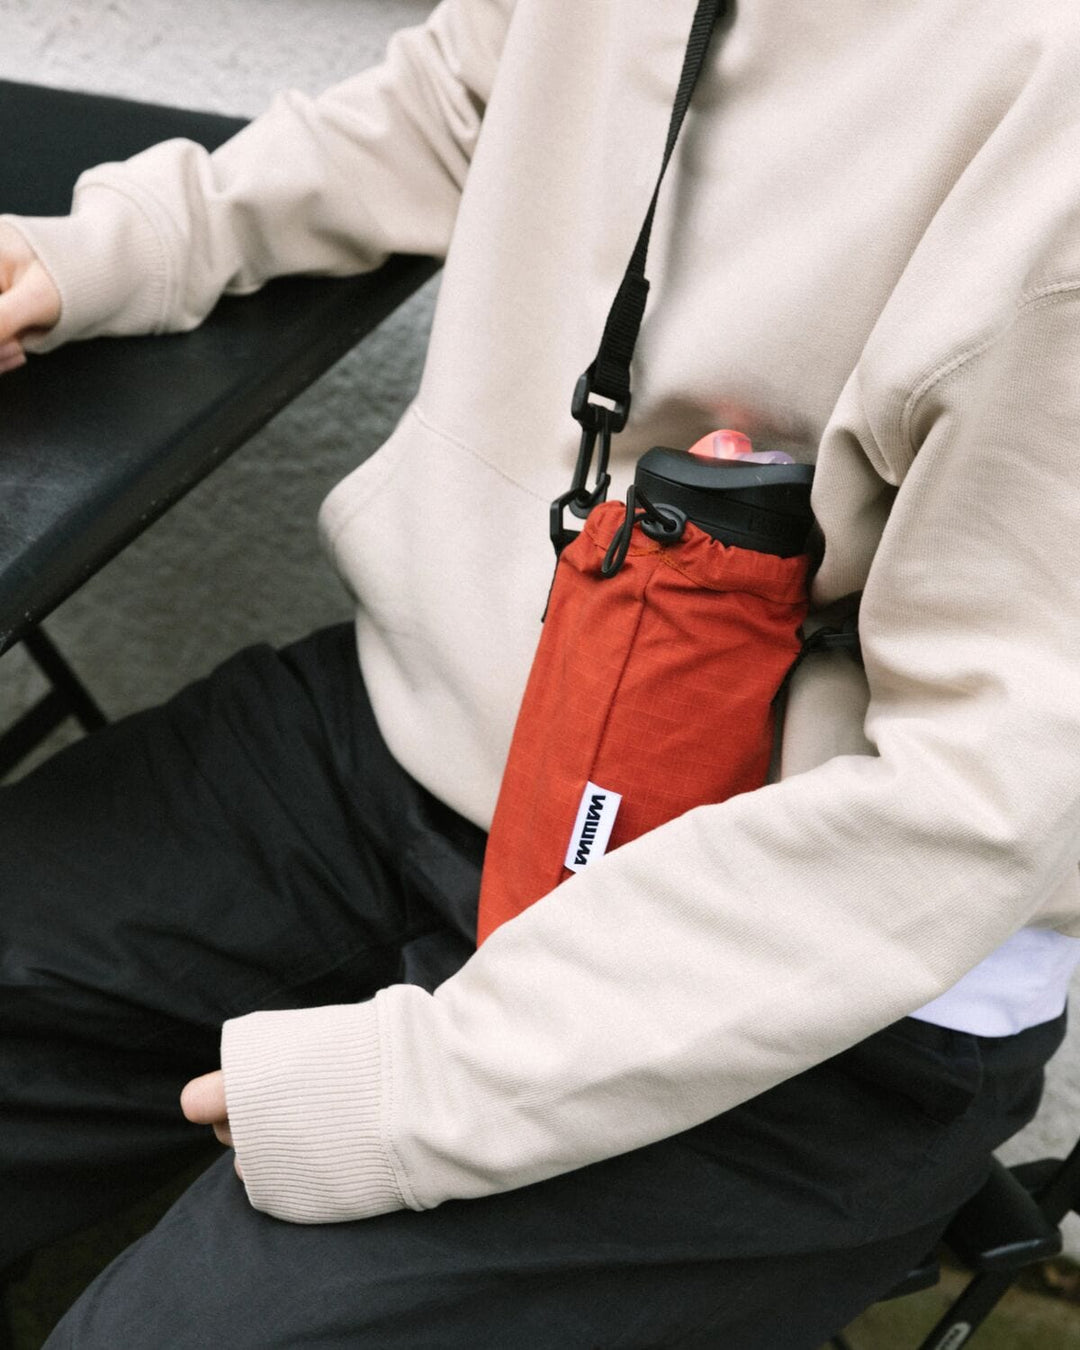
left=551, top=0, right=734, bottom=554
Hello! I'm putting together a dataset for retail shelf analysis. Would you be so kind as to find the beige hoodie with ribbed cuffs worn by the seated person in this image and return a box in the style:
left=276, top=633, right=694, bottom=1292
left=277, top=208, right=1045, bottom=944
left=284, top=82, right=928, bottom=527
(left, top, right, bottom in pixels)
left=8, top=0, right=1080, bottom=1222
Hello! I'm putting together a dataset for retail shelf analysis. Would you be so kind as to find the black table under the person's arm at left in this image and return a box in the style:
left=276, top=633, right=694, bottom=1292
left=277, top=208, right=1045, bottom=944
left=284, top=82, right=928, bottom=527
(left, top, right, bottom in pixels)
left=0, top=81, right=437, bottom=774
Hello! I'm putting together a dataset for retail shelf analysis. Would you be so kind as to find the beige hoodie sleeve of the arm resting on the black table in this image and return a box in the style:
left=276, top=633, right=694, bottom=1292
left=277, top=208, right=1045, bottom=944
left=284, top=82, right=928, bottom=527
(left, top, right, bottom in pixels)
left=4, top=0, right=512, bottom=351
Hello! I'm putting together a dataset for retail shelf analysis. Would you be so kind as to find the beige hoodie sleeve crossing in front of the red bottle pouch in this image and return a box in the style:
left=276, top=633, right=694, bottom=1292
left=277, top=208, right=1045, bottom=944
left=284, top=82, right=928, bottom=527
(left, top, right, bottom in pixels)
left=223, top=290, right=1080, bottom=1222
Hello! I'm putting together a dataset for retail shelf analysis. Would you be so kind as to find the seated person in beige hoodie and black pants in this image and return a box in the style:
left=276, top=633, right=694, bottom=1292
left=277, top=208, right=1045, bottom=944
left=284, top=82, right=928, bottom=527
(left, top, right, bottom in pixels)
left=0, top=0, right=1080, bottom=1350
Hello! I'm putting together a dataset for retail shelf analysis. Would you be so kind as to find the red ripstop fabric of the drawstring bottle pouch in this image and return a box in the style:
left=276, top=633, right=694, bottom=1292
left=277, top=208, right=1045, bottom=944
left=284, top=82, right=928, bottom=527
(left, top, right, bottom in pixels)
left=477, top=502, right=807, bottom=942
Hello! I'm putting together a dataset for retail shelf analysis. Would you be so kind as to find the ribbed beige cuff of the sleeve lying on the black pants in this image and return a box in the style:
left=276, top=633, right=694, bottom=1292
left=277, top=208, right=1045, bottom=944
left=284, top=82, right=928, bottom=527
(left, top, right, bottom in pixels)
left=221, top=1002, right=408, bottom=1223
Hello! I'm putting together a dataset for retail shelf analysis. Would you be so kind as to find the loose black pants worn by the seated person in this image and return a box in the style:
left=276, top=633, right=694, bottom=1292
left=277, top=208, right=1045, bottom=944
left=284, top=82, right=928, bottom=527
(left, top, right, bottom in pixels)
left=0, top=628, right=1062, bottom=1350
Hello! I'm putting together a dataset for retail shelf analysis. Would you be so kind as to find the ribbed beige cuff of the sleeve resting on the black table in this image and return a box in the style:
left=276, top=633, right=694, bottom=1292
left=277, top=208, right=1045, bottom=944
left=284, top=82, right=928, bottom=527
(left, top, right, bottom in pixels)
left=3, top=184, right=167, bottom=352
